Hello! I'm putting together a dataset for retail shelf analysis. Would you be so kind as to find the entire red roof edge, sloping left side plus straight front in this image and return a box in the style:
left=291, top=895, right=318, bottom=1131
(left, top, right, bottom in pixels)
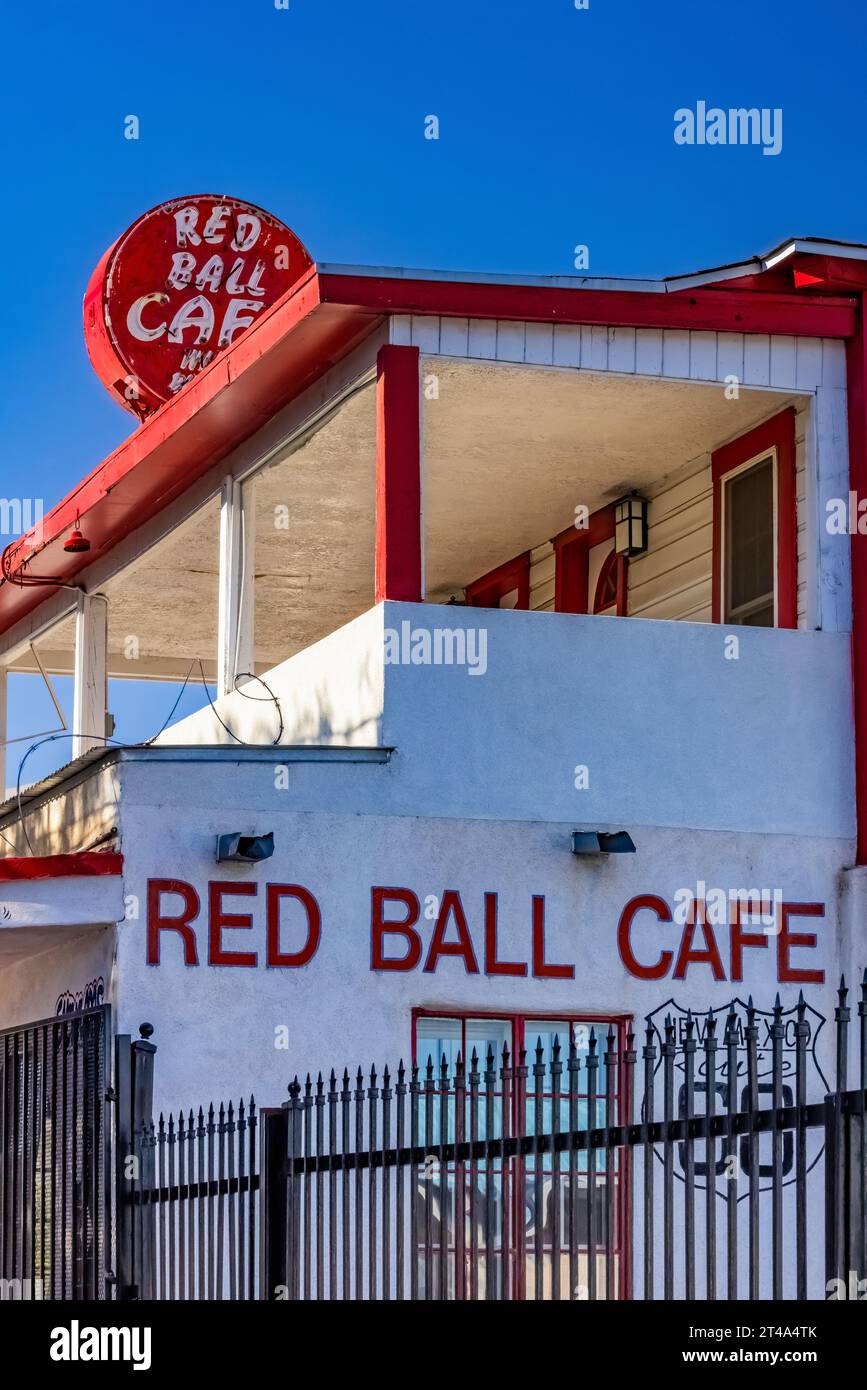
left=0, top=247, right=856, bottom=632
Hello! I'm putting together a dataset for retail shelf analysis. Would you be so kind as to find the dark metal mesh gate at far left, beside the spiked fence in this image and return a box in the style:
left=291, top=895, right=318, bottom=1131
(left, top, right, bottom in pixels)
left=0, top=1006, right=111, bottom=1300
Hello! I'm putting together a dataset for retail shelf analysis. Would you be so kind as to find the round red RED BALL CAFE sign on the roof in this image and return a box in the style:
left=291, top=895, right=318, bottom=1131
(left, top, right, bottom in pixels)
left=85, top=195, right=313, bottom=416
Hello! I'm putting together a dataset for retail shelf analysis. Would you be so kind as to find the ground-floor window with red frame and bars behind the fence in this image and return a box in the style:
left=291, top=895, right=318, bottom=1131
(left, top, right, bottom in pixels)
left=413, top=1009, right=629, bottom=1298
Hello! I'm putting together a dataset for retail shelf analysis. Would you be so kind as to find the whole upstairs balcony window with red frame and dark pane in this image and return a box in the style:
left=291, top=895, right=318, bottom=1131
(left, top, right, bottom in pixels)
left=711, top=407, right=798, bottom=627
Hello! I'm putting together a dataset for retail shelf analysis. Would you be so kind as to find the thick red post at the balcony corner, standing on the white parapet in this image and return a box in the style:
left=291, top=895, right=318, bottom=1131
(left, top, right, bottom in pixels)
left=375, top=343, right=424, bottom=603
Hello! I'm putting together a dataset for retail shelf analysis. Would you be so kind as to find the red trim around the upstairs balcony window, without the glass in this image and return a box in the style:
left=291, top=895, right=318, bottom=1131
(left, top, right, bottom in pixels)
left=710, top=406, right=798, bottom=628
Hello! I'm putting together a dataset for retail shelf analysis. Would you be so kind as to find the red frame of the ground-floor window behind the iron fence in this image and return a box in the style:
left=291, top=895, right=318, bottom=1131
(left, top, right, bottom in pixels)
left=411, top=1005, right=635, bottom=1301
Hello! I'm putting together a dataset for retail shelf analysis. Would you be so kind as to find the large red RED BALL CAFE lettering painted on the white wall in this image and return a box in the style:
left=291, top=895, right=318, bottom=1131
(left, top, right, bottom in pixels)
left=147, top=878, right=825, bottom=984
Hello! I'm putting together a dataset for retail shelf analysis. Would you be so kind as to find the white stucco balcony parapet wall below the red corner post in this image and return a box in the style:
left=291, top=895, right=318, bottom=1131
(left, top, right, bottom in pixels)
left=160, top=603, right=854, bottom=838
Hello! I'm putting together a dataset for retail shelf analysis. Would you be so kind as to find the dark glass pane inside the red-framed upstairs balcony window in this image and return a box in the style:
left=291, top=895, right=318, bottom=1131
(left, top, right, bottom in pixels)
left=725, top=457, right=775, bottom=627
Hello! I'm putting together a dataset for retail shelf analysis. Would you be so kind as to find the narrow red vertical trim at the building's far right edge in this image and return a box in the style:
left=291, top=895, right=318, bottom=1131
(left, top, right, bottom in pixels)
left=846, top=295, right=867, bottom=865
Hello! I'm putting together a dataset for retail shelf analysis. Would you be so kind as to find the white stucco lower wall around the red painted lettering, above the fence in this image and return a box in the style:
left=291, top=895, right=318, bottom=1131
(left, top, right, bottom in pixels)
left=108, top=763, right=850, bottom=1104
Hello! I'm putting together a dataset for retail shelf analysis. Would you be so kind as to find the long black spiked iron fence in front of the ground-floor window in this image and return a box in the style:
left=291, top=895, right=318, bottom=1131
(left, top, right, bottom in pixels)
left=118, top=976, right=867, bottom=1301
